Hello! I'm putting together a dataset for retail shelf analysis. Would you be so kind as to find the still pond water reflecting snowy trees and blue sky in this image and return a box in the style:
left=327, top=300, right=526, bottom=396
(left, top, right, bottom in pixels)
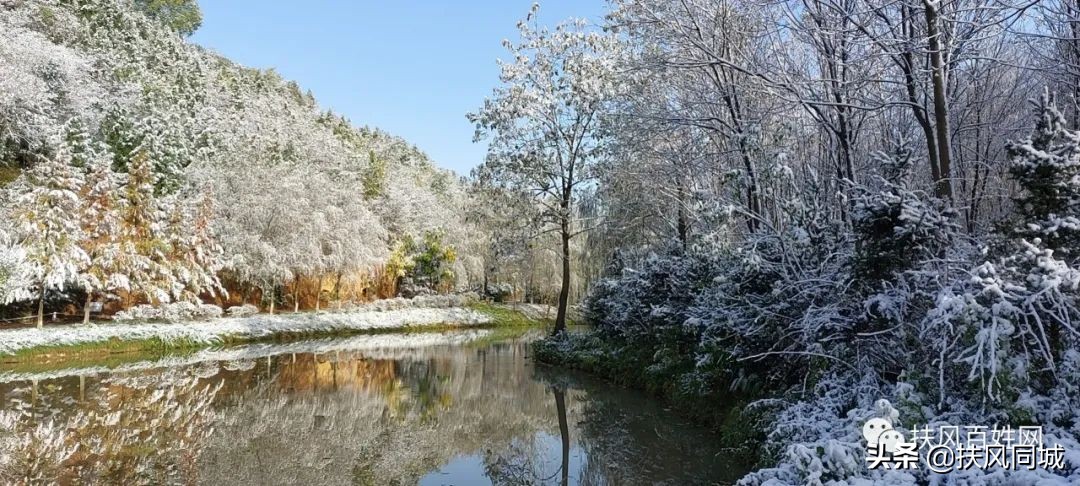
left=0, top=330, right=745, bottom=486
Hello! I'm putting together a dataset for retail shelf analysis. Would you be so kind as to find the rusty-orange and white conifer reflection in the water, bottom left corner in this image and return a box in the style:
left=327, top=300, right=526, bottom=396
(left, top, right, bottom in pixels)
left=0, top=372, right=220, bottom=484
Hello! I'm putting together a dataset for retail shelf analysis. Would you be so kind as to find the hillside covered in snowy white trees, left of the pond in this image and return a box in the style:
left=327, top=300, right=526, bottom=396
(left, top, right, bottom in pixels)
left=0, top=0, right=477, bottom=319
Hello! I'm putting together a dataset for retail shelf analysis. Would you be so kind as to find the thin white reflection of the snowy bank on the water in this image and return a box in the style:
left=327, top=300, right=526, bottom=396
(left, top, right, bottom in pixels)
left=0, top=329, right=491, bottom=383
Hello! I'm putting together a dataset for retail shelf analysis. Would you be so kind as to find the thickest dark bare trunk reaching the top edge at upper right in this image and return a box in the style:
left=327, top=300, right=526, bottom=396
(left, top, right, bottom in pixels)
left=922, top=0, right=953, bottom=202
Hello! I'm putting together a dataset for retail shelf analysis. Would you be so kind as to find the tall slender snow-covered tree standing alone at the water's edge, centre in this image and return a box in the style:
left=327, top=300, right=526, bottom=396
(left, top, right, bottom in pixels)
left=470, top=4, right=617, bottom=333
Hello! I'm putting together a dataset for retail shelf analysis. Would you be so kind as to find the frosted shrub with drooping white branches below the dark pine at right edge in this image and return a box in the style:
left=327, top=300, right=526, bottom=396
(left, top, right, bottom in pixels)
left=922, top=240, right=1080, bottom=402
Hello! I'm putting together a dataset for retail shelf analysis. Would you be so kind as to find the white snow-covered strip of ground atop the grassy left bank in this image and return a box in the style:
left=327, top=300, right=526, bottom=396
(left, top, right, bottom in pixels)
left=0, top=308, right=490, bottom=356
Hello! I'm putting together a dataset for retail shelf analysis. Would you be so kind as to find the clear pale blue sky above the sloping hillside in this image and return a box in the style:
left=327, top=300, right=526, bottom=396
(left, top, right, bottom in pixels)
left=191, top=0, right=607, bottom=174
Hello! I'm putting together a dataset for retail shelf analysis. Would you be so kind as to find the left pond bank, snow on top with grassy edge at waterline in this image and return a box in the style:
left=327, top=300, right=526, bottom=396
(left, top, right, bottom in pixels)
left=0, top=302, right=542, bottom=364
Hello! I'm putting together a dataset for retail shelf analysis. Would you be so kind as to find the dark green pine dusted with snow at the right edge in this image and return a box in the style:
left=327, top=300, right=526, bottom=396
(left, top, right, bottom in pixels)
left=1007, top=92, right=1080, bottom=261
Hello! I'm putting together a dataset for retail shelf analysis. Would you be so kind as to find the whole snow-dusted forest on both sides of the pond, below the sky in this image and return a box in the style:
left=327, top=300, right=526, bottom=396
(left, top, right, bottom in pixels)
left=6, top=0, right=1080, bottom=485
